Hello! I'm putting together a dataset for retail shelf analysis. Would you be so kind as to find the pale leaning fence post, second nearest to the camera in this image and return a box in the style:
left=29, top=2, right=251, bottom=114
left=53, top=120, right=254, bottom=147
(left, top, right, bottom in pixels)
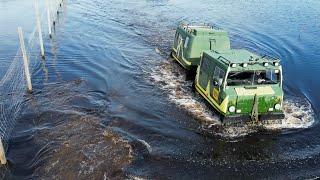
left=18, top=27, right=32, bottom=92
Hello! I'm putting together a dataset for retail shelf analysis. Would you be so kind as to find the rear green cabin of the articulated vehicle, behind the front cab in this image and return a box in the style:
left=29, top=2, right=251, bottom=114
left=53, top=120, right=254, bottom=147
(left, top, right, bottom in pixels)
left=171, top=24, right=230, bottom=70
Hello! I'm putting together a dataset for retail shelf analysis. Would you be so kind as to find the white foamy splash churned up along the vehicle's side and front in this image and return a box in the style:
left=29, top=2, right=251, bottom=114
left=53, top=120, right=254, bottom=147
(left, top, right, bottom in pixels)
left=150, top=61, right=314, bottom=138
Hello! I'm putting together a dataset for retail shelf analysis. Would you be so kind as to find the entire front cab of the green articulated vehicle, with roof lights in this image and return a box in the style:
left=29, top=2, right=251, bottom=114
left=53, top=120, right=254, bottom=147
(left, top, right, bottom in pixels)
left=195, top=49, right=284, bottom=123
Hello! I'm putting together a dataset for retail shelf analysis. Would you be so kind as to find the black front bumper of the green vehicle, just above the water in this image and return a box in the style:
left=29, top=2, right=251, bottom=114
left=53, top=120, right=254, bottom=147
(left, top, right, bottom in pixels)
left=221, top=112, right=285, bottom=124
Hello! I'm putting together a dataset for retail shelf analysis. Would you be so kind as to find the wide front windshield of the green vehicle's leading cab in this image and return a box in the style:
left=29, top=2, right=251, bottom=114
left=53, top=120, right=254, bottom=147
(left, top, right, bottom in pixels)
left=227, top=70, right=280, bottom=86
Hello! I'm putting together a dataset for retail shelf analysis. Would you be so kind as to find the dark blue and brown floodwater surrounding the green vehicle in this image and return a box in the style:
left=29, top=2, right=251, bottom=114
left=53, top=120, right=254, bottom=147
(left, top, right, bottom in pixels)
left=0, top=0, right=320, bottom=179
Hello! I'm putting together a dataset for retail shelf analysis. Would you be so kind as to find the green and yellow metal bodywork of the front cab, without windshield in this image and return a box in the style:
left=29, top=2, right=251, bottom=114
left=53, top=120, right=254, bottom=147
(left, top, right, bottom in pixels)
left=195, top=49, right=283, bottom=121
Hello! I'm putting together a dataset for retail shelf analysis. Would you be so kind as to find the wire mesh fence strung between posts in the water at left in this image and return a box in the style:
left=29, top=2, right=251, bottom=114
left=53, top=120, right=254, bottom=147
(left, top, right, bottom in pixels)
left=0, top=0, right=63, bottom=162
